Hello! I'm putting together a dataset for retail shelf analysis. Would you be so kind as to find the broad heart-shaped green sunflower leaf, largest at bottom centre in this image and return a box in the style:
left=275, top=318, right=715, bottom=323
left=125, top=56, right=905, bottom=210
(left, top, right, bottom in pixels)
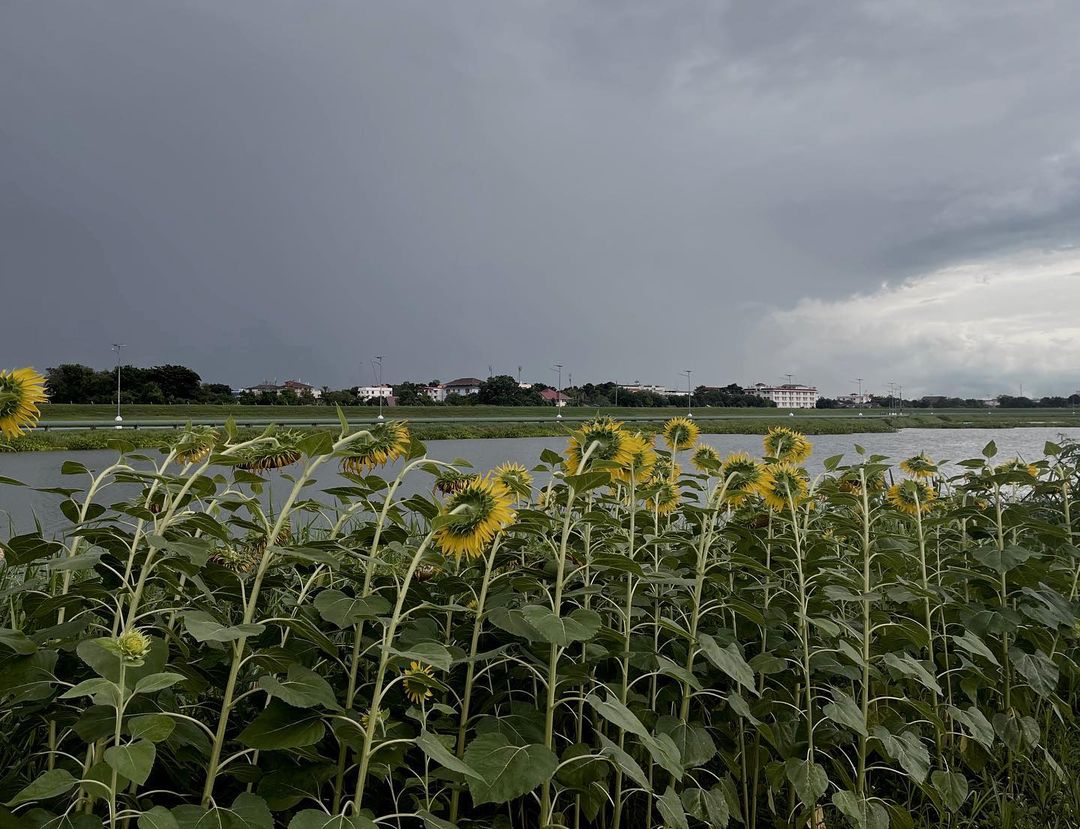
left=464, top=732, right=558, bottom=805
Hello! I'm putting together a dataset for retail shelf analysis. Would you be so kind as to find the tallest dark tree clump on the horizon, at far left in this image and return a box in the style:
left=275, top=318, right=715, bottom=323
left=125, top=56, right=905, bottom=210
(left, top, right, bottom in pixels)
left=45, top=363, right=233, bottom=404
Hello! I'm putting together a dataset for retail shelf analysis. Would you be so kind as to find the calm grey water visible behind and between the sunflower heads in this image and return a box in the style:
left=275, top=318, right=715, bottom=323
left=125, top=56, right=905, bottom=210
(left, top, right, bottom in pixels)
left=0, top=426, right=1080, bottom=538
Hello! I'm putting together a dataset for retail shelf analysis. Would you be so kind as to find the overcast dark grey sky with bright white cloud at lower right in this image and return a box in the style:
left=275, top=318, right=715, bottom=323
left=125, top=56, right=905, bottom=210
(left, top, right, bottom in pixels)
left=0, top=0, right=1080, bottom=395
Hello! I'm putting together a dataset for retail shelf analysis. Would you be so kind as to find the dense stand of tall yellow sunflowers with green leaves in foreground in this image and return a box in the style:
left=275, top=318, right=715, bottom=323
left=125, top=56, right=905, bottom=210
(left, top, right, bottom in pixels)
left=0, top=397, right=1080, bottom=829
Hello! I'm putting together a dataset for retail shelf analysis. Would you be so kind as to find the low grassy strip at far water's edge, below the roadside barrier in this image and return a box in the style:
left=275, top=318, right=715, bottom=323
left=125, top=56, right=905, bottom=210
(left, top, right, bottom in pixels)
left=0, top=413, right=1080, bottom=454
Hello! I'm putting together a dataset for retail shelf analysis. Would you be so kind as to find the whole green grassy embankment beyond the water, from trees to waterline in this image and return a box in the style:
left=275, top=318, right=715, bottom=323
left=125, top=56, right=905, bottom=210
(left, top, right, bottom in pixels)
left=0, top=404, right=1080, bottom=451
